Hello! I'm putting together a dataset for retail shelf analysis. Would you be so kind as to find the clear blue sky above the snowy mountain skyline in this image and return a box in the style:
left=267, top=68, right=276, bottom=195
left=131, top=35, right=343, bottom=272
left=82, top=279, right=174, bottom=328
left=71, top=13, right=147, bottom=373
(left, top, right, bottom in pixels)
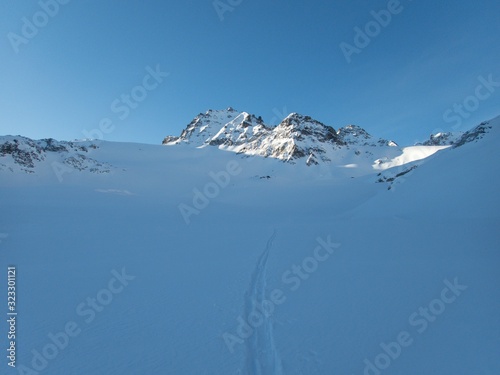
left=0, top=0, right=500, bottom=144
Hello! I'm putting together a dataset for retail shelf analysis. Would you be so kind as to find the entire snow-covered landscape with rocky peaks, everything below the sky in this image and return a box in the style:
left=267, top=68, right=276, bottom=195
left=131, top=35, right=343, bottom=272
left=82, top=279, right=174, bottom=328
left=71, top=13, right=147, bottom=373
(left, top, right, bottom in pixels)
left=0, top=110, right=500, bottom=375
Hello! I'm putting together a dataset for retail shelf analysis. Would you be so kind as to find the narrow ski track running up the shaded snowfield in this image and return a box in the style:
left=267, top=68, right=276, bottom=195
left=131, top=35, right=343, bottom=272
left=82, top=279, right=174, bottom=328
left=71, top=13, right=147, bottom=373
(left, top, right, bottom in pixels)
left=244, top=230, right=283, bottom=375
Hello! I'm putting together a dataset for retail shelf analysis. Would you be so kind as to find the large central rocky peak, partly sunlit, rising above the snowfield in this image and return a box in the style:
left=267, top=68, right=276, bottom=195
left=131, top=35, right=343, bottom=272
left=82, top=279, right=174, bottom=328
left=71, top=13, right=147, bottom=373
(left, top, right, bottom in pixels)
left=163, top=108, right=398, bottom=165
